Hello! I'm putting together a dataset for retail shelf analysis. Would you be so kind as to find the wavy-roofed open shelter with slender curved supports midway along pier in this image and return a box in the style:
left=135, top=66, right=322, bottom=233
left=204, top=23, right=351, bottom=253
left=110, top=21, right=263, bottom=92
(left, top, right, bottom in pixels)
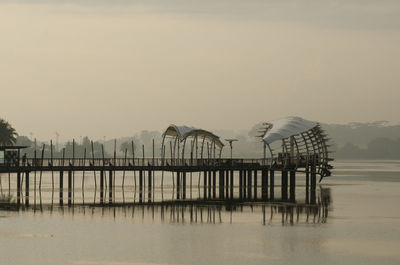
left=161, top=124, right=224, bottom=161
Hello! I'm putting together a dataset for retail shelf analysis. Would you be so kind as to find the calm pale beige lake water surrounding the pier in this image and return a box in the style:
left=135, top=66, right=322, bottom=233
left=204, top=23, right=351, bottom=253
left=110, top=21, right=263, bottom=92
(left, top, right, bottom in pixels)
left=0, top=161, right=400, bottom=265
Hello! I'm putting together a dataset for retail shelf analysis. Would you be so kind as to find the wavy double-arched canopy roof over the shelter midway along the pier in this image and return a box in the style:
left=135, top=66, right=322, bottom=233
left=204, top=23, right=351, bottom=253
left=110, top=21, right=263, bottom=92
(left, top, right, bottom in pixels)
left=164, top=124, right=224, bottom=148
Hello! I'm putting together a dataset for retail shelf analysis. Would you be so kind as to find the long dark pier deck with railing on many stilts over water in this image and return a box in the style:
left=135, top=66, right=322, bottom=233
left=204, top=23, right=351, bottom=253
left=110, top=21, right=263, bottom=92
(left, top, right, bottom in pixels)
left=0, top=157, right=317, bottom=205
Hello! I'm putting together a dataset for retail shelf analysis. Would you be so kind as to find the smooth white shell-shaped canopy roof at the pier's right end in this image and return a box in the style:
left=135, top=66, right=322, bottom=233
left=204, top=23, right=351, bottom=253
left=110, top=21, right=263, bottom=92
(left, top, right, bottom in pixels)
left=263, top=117, right=318, bottom=144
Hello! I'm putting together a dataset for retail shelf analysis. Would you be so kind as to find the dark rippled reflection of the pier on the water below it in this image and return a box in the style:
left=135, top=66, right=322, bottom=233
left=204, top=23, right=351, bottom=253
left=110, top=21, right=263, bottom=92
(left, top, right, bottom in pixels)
left=7, top=188, right=331, bottom=225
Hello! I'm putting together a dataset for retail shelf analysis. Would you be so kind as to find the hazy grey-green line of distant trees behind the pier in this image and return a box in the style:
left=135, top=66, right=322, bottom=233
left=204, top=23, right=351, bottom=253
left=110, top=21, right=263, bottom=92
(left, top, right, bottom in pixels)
left=8, top=122, right=400, bottom=159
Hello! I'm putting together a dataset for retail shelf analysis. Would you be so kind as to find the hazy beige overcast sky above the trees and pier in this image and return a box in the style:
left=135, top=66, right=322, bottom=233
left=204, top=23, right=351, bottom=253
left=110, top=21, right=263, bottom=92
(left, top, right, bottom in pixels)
left=0, top=0, right=400, bottom=139
